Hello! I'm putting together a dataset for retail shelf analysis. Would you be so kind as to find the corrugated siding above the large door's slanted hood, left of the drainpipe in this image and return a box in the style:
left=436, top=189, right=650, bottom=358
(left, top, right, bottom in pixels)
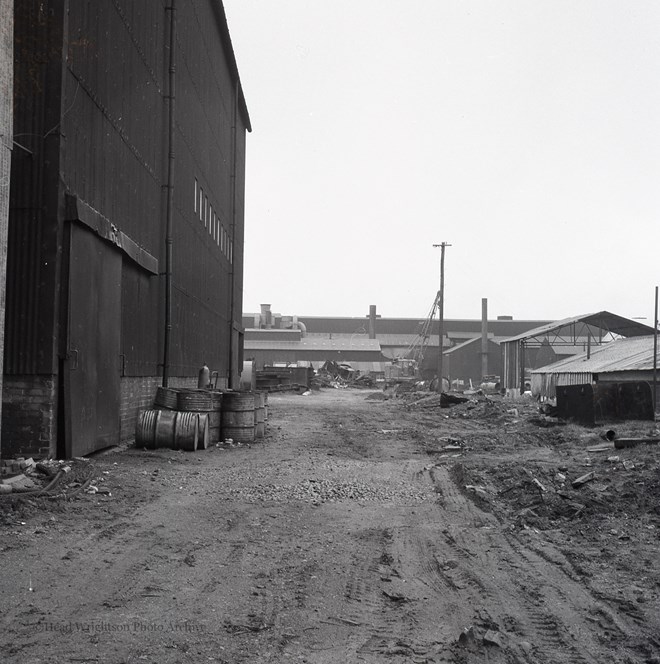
left=62, top=0, right=167, bottom=257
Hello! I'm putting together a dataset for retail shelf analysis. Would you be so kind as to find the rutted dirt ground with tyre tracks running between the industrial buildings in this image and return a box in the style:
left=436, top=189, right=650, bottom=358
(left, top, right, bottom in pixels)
left=0, top=390, right=660, bottom=664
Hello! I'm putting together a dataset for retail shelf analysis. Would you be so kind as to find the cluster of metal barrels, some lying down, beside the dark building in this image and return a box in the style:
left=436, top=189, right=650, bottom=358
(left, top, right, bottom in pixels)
left=135, top=387, right=268, bottom=452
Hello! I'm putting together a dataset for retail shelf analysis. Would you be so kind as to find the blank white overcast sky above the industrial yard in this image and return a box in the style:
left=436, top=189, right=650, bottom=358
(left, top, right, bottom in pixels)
left=224, top=0, right=660, bottom=324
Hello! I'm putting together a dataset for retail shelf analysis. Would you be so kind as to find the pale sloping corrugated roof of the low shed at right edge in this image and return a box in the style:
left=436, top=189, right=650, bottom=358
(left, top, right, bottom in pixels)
left=532, top=335, right=653, bottom=374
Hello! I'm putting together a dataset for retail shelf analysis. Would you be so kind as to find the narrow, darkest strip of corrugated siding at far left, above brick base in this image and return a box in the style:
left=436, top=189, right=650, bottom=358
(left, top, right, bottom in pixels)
left=4, top=0, right=61, bottom=375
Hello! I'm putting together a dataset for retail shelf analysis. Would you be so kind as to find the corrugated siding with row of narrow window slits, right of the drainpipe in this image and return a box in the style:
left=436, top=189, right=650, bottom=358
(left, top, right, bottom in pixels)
left=172, top=0, right=245, bottom=375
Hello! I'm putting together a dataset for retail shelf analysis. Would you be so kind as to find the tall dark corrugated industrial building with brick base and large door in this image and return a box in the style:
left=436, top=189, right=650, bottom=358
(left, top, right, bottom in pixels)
left=2, top=0, right=251, bottom=456
